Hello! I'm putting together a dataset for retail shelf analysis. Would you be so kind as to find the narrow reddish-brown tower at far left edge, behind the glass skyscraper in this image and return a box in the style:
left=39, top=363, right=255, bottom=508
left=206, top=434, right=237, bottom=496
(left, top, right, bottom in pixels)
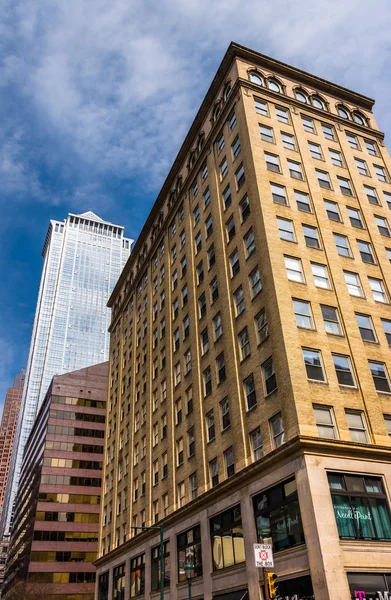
left=0, top=369, right=25, bottom=511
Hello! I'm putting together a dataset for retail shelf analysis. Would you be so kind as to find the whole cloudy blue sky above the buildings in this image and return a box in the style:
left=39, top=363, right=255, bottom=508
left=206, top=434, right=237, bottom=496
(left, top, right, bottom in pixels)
left=0, top=0, right=391, bottom=402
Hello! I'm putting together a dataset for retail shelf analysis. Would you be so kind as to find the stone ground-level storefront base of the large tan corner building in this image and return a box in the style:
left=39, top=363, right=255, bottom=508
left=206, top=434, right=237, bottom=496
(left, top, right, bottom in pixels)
left=95, top=440, right=391, bottom=600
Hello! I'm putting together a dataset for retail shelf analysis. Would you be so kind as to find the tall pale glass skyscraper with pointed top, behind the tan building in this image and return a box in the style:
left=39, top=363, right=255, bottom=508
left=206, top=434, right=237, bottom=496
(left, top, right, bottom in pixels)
left=0, top=212, right=133, bottom=536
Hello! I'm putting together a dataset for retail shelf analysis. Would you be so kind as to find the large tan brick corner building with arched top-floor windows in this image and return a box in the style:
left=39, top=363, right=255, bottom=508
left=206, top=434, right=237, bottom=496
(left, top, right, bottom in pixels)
left=96, top=44, right=391, bottom=600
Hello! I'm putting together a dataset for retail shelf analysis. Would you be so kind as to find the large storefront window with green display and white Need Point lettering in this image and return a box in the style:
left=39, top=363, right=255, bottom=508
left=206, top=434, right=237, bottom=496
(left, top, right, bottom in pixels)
left=327, top=472, right=391, bottom=540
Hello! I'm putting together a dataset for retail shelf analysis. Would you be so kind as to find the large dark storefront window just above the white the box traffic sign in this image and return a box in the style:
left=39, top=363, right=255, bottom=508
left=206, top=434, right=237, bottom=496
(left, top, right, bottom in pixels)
left=253, top=479, right=305, bottom=552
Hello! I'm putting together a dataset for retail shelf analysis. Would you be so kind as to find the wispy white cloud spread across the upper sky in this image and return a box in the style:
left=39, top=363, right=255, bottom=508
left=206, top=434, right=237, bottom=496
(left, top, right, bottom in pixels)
left=0, top=0, right=391, bottom=202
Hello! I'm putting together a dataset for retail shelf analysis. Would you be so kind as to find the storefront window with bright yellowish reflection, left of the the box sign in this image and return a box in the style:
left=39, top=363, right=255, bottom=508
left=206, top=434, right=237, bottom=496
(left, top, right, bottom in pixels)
left=209, top=505, right=245, bottom=571
